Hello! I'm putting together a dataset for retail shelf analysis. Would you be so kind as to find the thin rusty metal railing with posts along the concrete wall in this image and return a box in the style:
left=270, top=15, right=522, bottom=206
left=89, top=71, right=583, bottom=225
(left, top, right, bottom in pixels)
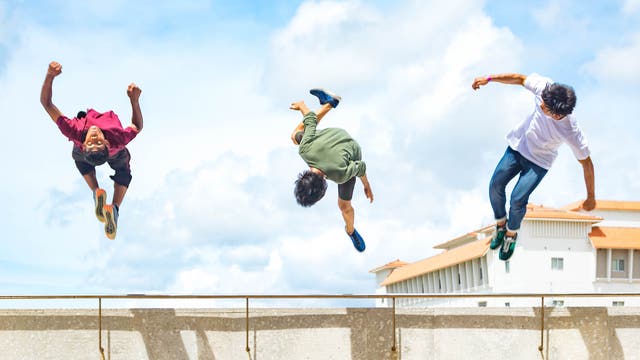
left=0, top=293, right=640, bottom=360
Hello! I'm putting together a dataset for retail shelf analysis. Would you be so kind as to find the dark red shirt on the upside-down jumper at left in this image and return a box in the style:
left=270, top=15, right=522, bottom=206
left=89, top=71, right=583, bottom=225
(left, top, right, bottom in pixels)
left=56, top=109, right=138, bottom=157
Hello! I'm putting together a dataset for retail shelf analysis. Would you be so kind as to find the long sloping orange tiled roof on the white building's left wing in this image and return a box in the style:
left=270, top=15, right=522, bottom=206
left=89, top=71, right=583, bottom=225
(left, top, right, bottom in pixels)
left=380, top=238, right=491, bottom=286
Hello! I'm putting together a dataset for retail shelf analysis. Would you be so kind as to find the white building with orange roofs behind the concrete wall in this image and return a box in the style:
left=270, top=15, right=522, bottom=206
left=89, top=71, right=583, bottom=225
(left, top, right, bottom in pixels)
left=371, top=200, right=640, bottom=307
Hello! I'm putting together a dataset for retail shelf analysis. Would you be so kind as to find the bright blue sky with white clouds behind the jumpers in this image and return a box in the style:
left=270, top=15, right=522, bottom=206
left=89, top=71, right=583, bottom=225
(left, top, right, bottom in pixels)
left=0, top=0, right=640, bottom=306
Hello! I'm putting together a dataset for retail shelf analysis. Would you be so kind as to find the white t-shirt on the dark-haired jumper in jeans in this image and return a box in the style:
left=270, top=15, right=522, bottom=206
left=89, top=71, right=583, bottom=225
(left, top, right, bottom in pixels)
left=507, top=74, right=590, bottom=170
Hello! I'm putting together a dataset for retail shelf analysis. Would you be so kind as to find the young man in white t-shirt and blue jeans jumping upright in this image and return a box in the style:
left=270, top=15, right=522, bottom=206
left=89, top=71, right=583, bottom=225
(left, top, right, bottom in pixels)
left=471, top=74, right=596, bottom=260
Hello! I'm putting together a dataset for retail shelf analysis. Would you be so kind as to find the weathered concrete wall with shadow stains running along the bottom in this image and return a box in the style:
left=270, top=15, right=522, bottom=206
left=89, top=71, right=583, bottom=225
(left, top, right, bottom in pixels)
left=0, top=307, right=640, bottom=360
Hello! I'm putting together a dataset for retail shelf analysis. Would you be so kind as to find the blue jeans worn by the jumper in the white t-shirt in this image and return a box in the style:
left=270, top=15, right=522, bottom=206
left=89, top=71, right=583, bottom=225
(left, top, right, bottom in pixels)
left=489, top=147, right=547, bottom=231
